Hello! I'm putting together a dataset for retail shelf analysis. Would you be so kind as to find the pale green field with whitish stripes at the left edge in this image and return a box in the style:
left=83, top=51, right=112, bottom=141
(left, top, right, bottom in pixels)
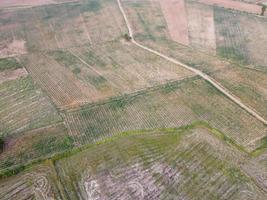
left=0, top=76, right=61, bottom=136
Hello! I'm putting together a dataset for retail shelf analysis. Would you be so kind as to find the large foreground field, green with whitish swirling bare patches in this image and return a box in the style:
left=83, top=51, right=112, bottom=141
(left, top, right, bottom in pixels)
left=55, top=128, right=266, bottom=200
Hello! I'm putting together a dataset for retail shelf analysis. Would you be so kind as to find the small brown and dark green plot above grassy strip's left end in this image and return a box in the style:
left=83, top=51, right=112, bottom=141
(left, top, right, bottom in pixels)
left=0, top=123, right=74, bottom=170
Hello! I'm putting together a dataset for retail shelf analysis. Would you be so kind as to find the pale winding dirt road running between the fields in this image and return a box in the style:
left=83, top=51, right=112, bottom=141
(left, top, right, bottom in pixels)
left=117, top=0, right=267, bottom=126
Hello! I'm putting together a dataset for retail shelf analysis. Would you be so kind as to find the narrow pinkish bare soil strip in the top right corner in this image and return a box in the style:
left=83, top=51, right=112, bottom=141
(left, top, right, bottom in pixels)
left=198, top=0, right=266, bottom=15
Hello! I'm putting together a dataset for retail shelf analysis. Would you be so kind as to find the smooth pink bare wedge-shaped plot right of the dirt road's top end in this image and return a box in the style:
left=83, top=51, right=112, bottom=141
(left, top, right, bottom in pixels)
left=160, top=0, right=189, bottom=45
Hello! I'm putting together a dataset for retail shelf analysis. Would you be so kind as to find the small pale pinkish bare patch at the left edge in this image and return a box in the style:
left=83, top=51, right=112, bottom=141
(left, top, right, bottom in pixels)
left=0, top=40, right=27, bottom=58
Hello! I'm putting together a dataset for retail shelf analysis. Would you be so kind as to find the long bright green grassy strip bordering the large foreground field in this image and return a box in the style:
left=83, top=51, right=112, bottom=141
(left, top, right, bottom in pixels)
left=0, top=121, right=249, bottom=178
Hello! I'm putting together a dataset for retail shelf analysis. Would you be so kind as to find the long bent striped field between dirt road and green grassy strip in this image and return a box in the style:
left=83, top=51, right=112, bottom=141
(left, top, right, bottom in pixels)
left=64, top=78, right=267, bottom=149
